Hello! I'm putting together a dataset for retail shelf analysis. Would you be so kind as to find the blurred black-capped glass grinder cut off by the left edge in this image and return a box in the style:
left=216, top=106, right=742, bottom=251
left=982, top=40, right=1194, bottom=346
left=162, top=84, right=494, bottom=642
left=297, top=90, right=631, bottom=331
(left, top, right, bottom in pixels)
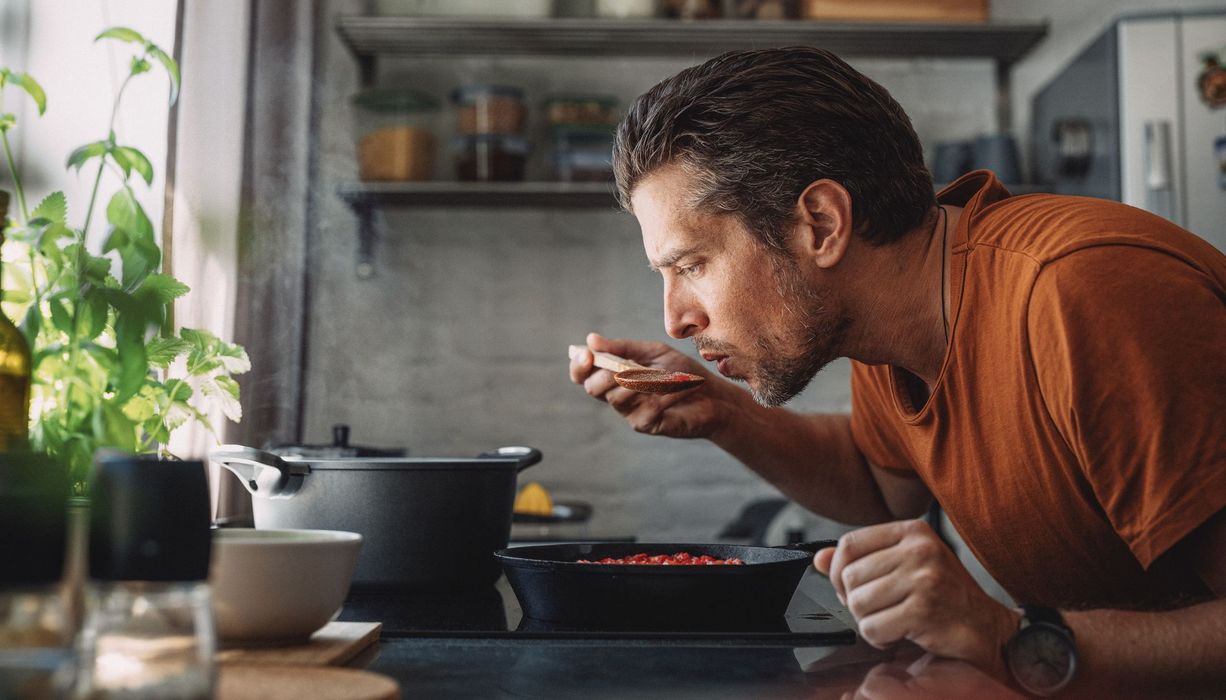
left=0, top=452, right=75, bottom=699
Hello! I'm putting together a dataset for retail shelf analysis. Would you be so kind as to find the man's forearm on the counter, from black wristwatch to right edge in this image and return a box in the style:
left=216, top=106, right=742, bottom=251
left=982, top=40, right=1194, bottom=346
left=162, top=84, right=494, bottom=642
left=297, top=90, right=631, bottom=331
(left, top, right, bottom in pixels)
left=1064, top=599, right=1226, bottom=698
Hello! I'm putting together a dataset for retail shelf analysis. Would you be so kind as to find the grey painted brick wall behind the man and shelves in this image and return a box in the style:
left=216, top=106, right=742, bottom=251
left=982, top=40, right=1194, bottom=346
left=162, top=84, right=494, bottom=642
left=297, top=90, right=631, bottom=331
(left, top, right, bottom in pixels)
left=305, top=0, right=1206, bottom=539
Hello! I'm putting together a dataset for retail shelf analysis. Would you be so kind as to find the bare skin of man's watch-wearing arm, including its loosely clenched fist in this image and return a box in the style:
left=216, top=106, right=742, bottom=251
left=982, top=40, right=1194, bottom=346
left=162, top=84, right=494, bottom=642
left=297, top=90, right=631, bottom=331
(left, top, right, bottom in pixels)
left=814, top=510, right=1226, bottom=698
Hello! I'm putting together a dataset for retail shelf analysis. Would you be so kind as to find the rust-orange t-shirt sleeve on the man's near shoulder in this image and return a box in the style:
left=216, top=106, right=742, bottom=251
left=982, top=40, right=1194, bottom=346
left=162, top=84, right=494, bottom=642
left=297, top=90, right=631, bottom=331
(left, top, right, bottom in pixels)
left=1027, top=245, right=1226, bottom=568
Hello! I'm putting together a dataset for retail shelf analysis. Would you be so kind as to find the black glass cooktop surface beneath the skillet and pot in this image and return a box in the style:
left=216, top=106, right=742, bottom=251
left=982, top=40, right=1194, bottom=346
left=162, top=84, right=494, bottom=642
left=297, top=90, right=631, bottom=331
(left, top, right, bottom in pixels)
left=340, top=571, right=856, bottom=647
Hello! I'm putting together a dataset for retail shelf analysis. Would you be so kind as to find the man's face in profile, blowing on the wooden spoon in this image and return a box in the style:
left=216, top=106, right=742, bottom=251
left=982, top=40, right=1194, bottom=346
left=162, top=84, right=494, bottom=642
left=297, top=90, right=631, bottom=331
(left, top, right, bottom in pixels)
left=630, top=167, right=848, bottom=406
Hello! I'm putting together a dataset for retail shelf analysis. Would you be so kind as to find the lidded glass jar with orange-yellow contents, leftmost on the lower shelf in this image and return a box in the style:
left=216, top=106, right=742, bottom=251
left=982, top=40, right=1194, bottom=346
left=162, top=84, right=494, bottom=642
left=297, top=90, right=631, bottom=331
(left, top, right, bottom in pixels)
left=351, top=88, right=439, bottom=181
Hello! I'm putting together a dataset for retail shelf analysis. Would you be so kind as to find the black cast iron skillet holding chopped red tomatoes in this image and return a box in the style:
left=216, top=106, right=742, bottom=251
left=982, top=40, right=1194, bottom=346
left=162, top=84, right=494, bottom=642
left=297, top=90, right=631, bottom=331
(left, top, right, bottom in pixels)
left=494, top=539, right=837, bottom=629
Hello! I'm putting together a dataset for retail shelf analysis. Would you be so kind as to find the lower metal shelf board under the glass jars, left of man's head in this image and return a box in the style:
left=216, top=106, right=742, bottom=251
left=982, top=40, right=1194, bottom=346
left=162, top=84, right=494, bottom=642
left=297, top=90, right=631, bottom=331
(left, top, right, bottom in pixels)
left=337, top=181, right=617, bottom=210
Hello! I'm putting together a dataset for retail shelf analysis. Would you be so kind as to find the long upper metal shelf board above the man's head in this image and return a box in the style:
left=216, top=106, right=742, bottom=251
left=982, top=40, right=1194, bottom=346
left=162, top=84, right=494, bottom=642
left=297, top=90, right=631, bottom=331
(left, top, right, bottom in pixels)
left=336, top=15, right=1047, bottom=65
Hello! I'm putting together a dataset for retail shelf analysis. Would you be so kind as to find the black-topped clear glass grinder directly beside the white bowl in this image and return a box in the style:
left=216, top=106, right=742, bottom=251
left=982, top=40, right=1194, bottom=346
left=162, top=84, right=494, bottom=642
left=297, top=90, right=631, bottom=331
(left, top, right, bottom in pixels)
left=75, top=454, right=217, bottom=700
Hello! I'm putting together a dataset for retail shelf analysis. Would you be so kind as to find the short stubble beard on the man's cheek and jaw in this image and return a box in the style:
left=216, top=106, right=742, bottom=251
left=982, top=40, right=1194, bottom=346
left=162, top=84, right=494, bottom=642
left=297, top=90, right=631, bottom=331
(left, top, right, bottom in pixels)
left=694, top=253, right=851, bottom=408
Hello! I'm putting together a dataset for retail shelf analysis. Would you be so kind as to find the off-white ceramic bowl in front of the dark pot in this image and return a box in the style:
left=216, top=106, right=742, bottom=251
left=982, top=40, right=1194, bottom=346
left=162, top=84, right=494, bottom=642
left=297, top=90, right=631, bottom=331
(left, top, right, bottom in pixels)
left=208, top=528, right=362, bottom=642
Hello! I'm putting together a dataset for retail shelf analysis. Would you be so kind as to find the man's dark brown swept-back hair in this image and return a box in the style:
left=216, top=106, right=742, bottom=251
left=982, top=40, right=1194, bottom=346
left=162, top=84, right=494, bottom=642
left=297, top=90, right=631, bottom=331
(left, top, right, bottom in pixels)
left=613, top=47, right=937, bottom=250
